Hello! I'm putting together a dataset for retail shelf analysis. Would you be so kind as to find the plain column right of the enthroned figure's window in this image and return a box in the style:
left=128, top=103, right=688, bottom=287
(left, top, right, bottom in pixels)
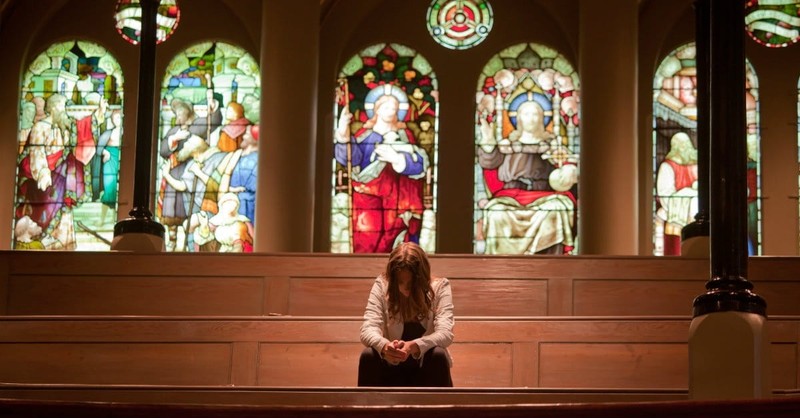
left=578, top=0, right=639, bottom=255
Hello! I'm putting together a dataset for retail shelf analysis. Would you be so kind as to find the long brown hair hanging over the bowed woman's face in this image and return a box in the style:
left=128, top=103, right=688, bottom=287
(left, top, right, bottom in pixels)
left=384, top=242, right=433, bottom=321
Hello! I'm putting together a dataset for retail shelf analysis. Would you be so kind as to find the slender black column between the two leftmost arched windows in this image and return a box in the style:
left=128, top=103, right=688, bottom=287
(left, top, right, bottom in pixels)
left=114, top=0, right=164, bottom=239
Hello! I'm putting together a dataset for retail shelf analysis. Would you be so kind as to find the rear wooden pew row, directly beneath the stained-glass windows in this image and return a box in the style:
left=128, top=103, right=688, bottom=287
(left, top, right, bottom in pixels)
left=0, top=251, right=800, bottom=316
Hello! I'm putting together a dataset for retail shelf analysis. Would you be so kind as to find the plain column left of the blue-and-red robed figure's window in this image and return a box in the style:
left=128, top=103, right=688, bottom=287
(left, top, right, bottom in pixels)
left=255, top=0, right=320, bottom=252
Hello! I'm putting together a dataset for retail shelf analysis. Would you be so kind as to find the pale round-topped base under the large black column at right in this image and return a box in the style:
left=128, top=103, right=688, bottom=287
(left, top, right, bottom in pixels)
left=689, top=311, right=772, bottom=400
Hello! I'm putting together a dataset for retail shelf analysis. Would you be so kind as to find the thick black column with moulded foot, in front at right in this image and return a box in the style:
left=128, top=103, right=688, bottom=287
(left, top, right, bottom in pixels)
left=693, top=0, right=766, bottom=317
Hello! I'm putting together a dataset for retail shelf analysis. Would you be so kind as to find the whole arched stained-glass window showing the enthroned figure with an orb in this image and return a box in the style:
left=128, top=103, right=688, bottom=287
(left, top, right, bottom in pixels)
left=474, top=43, right=580, bottom=254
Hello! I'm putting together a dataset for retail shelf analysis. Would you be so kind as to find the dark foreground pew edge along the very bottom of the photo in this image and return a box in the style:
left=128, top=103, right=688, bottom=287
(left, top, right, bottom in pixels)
left=0, top=397, right=800, bottom=418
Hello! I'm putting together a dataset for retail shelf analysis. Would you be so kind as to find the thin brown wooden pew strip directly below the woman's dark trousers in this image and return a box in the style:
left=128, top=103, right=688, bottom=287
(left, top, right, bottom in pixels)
left=0, top=383, right=688, bottom=404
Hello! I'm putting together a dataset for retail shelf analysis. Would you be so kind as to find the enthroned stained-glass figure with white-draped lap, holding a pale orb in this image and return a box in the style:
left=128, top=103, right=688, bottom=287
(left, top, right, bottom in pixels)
left=477, top=69, right=578, bottom=254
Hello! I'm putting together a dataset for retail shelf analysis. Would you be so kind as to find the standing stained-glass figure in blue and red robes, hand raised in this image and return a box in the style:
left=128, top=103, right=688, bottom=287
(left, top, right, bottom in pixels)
left=335, top=84, right=430, bottom=253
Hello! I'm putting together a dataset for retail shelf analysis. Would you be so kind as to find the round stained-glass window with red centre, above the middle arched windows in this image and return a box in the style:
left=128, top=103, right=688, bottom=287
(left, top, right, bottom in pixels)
left=427, top=0, right=494, bottom=49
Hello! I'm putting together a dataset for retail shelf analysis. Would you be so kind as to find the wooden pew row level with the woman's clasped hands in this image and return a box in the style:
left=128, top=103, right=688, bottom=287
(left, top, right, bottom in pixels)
left=0, top=316, right=800, bottom=390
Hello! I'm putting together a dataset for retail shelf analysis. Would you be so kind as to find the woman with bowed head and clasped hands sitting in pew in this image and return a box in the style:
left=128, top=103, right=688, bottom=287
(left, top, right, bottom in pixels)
left=358, top=242, right=454, bottom=387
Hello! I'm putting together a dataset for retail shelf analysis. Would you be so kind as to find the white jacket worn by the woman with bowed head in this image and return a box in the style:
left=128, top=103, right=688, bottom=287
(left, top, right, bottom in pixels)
left=361, top=275, right=455, bottom=367
